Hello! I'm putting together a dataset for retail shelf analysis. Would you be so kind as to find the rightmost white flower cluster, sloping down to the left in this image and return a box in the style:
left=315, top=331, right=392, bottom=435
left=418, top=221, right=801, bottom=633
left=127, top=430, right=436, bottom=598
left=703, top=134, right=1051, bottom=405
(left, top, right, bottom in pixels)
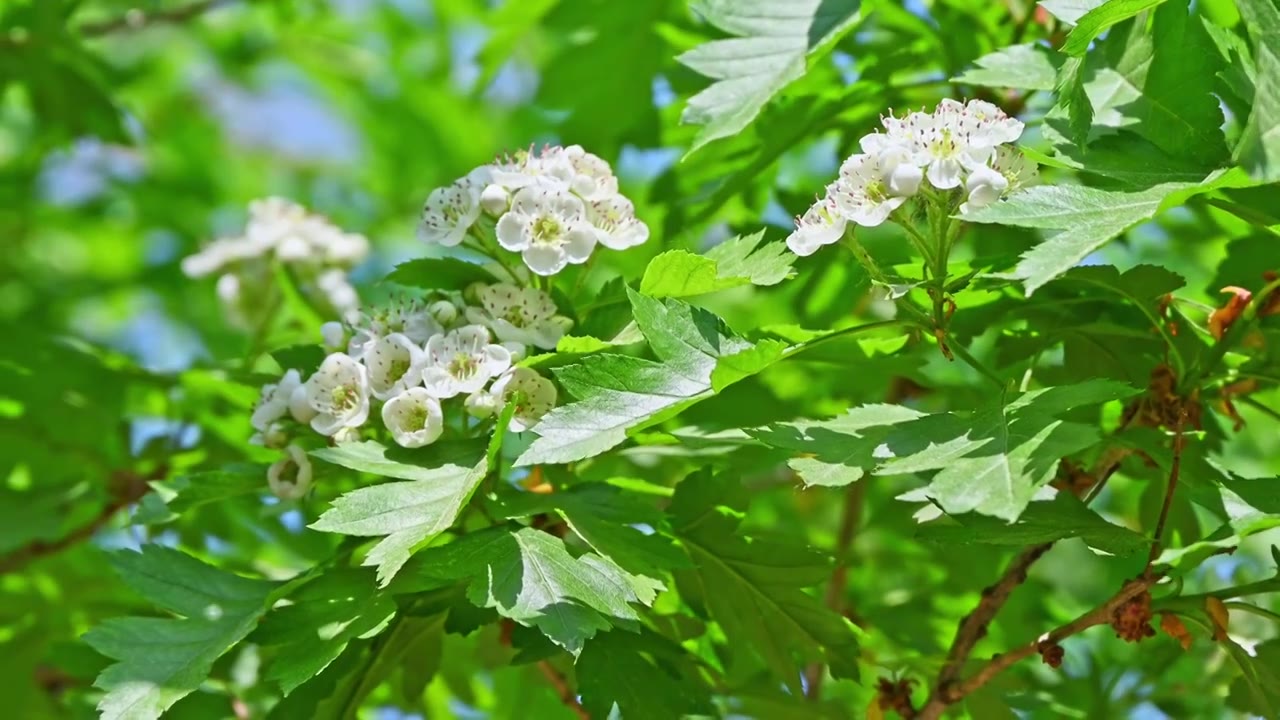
left=787, top=100, right=1037, bottom=255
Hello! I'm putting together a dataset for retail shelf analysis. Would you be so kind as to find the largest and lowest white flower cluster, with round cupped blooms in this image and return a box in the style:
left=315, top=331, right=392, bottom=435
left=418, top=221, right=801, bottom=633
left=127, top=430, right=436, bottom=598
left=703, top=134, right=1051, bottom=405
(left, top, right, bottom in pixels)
left=251, top=284, right=571, bottom=498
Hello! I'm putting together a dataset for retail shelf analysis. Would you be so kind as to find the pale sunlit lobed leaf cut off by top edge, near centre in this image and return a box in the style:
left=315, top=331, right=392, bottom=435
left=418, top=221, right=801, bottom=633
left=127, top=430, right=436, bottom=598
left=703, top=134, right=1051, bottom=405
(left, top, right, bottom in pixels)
left=677, top=0, right=860, bottom=152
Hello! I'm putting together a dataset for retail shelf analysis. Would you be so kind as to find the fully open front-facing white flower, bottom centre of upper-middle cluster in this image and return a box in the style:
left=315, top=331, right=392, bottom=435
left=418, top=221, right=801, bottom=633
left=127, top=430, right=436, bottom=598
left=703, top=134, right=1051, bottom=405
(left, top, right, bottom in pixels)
left=497, top=186, right=595, bottom=275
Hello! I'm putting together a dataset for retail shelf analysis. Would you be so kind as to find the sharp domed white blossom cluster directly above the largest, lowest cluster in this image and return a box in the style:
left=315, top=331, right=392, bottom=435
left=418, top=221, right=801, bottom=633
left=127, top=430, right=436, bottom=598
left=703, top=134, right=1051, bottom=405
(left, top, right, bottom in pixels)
left=419, top=145, right=649, bottom=275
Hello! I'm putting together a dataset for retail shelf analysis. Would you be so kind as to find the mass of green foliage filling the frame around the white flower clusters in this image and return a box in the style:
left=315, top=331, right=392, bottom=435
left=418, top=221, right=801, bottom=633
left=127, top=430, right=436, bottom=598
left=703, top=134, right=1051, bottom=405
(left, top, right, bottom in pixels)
left=0, top=0, right=1280, bottom=720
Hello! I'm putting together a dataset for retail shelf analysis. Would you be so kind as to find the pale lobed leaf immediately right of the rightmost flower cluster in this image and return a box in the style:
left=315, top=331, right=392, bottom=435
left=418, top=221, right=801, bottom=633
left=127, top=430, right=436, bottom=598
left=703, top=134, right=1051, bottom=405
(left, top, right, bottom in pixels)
left=965, top=174, right=1240, bottom=295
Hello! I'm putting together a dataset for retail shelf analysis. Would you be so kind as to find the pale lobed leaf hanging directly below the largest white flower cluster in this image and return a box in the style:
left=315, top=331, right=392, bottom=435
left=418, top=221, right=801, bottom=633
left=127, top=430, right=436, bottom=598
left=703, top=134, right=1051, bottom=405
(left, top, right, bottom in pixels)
left=311, top=441, right=490, bottom=587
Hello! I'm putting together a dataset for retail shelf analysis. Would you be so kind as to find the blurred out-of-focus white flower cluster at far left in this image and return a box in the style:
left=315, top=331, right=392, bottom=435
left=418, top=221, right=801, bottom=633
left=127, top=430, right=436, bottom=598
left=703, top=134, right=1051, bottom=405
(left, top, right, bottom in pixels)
left=182, top=197, right=369, bottom=325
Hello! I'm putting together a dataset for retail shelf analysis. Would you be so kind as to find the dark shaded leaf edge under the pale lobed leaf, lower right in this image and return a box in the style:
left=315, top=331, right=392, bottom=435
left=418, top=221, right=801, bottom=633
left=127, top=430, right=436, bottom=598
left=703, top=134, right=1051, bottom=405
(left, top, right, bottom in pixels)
left=915, top=492, right=1151, bottom=555
